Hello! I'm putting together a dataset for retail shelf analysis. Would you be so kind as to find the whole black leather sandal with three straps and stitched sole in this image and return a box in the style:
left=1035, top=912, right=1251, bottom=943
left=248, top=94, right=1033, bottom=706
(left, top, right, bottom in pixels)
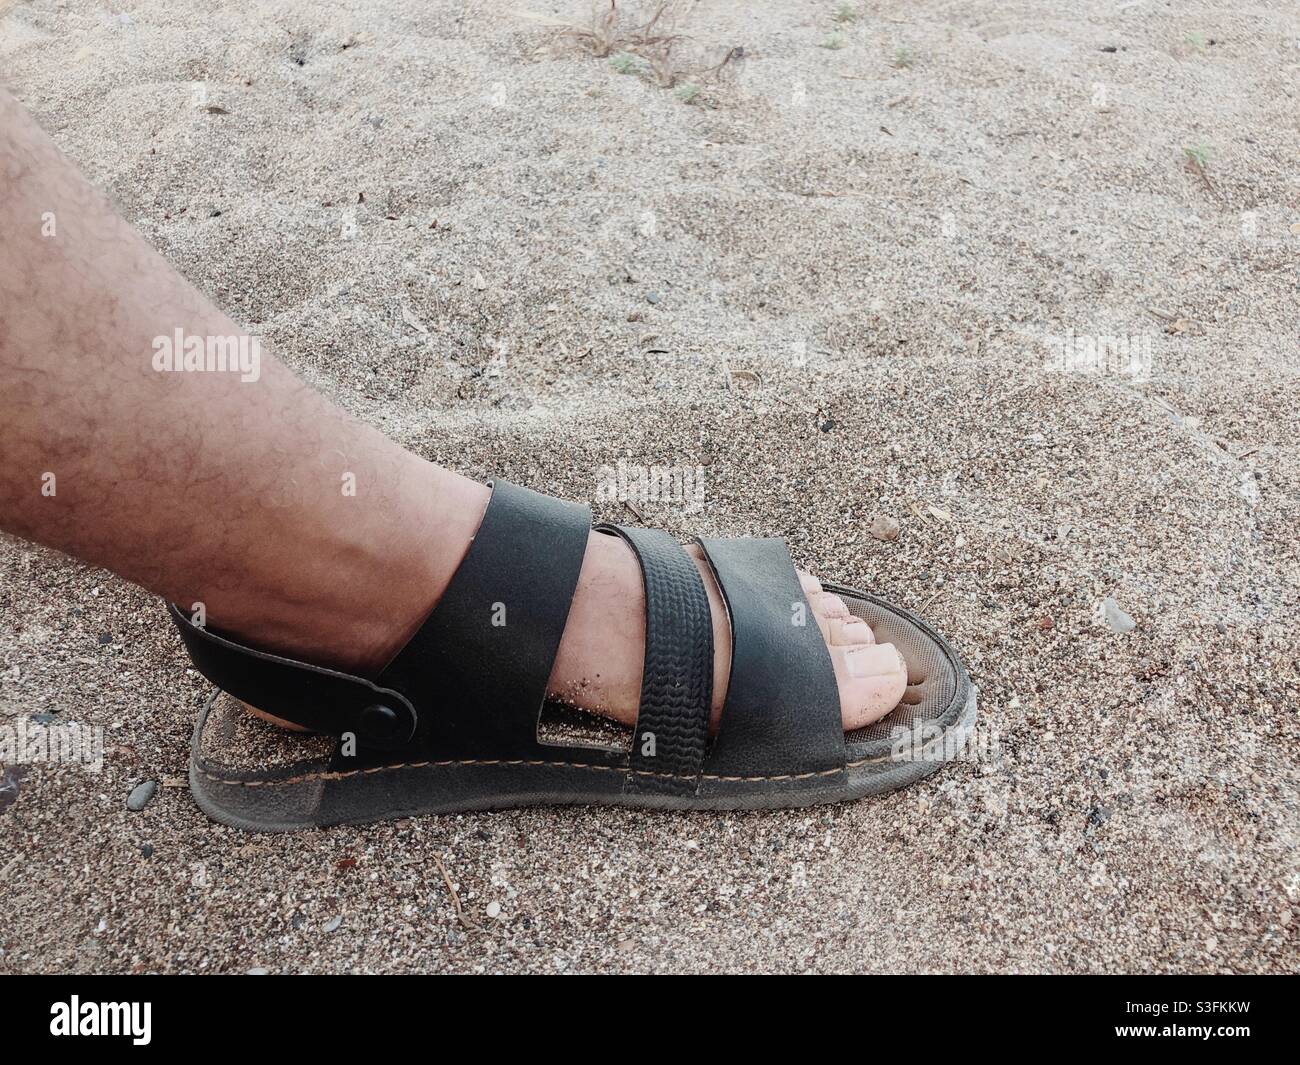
left=172, top=481, right=975, bottom=830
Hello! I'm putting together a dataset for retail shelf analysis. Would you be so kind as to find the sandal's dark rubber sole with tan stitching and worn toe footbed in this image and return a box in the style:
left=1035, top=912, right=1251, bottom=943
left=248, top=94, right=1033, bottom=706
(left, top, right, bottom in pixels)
left=190, top=584, right=978, bottom=832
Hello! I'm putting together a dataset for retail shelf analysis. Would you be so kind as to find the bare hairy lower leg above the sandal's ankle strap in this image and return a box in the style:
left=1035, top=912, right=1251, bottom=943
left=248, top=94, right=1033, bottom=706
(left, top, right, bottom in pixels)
left=0, top=90, right=488, bottom=670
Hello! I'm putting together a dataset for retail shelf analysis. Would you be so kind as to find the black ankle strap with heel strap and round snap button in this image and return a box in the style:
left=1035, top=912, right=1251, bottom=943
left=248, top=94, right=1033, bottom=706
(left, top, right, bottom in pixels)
left=170, top=481, right=592, bottom=763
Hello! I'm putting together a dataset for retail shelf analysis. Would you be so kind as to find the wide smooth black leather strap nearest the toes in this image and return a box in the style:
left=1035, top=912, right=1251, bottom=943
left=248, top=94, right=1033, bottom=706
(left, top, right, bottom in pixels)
left=697, top=537, right=846, bottom=776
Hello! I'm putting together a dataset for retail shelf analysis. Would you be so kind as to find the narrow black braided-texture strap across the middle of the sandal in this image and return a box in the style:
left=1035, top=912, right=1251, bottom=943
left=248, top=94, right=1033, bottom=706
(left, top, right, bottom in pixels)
left=597, top=524, right=714, bottom=795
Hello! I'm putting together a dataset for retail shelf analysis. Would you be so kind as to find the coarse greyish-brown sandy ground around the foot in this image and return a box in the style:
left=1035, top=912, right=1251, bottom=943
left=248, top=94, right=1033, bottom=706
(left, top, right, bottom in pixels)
left=0, top=0, right=1300, bottom=973
